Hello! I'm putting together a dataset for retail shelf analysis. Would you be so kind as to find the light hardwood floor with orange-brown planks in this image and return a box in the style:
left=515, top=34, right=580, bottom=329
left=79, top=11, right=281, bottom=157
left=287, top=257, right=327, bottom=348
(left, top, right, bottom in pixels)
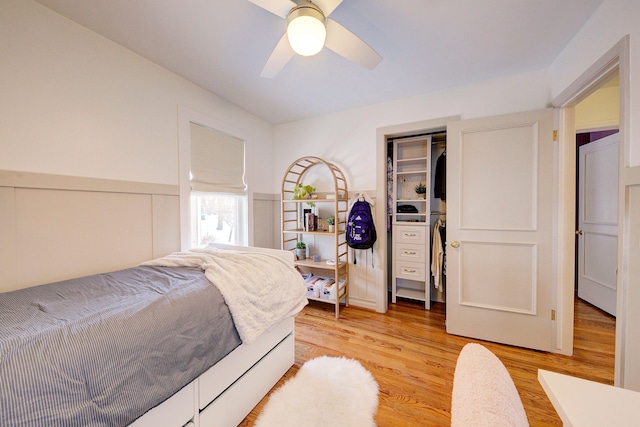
left=241, top=299, right=615, bottom=427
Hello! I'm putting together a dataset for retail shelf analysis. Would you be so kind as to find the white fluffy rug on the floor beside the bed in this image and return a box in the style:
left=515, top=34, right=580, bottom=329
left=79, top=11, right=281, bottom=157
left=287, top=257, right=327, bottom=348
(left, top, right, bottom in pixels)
left=255, top=356, right=378, bottom=427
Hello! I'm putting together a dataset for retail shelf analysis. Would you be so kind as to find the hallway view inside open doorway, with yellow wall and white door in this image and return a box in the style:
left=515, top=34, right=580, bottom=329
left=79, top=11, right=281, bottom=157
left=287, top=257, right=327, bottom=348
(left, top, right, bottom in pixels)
left=574, top=74, right=620, bottom=378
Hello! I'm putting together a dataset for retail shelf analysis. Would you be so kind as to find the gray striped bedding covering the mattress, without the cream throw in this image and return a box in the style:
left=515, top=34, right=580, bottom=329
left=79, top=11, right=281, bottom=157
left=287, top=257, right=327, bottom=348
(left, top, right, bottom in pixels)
left=0, top=266, right=241, bottom=427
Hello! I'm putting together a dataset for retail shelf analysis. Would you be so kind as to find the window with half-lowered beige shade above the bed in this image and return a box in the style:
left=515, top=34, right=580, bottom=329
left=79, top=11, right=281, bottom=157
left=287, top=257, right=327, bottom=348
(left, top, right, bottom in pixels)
left=190, top=123, right=247, bottom=248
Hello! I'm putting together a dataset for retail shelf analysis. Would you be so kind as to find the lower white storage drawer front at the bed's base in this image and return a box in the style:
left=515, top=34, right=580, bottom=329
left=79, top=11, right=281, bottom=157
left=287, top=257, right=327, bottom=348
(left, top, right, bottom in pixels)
left=200, top=334, right=295, bottom=427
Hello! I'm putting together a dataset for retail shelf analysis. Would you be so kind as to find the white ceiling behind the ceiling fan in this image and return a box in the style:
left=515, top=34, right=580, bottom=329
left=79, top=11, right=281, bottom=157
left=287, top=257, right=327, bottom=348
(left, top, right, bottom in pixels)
left=37, top=0, right=603, bottom=124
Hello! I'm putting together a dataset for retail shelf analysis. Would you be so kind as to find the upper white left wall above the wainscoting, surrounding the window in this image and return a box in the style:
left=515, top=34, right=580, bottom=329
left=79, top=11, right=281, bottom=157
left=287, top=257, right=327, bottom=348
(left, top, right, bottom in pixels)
left=0, top=0, right=277, bottom=192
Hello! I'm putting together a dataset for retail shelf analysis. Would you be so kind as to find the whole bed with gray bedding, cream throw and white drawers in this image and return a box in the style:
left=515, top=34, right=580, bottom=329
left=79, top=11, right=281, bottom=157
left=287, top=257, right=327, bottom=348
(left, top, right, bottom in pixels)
left=0, top=249, right=306, bottom=427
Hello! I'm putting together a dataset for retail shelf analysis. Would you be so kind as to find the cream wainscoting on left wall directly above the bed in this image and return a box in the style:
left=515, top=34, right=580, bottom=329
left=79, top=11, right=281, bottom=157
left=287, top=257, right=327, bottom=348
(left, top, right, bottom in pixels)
left=0, top=171, right=180, bottom=292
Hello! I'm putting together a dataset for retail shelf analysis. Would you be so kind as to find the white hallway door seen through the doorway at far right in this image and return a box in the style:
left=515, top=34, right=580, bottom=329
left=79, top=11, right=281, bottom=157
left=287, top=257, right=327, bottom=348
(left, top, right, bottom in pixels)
left=578, top=133, right=619, bottom=316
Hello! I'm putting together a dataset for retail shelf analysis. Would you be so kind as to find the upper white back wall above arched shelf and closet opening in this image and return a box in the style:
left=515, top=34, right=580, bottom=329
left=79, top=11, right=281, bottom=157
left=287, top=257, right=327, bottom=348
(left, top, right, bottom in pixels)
left=274, top=71, right=548, bottom=191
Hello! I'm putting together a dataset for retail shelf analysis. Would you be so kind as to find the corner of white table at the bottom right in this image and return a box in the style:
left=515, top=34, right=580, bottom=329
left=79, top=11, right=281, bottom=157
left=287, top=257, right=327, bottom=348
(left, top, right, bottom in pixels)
left=538, top=369, right=640, bottom=427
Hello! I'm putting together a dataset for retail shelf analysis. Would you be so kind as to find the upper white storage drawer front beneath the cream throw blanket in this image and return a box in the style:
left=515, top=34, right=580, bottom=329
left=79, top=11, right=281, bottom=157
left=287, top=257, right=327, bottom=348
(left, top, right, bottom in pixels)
left=198, top=317, right=294, bottom=410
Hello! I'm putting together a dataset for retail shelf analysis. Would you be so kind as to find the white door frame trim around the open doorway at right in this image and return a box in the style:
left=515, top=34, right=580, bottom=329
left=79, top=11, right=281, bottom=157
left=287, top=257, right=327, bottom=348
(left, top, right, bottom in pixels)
left=551, top=35, right=633, bottom=387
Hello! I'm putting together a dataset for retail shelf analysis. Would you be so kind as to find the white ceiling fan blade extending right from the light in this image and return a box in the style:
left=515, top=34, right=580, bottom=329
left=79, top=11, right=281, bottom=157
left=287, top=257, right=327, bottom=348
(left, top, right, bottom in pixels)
left=324, top=18, right=382, bottom=70
